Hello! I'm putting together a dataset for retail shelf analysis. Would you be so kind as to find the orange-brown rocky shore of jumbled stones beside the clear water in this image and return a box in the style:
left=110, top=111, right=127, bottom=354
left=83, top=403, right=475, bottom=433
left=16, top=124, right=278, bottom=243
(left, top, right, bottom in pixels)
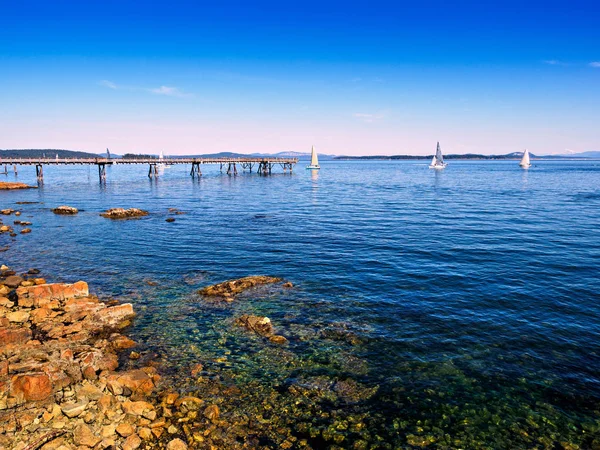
left=0, top=266, right=219, bottom=450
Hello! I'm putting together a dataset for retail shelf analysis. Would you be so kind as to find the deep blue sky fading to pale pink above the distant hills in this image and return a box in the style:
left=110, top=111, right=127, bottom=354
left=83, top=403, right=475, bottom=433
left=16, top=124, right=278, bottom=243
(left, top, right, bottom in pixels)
left=0, top=0, right=600, bottom=155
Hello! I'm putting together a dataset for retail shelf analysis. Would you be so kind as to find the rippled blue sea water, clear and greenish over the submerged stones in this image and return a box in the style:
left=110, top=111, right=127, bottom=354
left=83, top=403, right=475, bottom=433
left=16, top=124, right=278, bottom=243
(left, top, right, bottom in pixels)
left=0, top=161, right=600, bottom=449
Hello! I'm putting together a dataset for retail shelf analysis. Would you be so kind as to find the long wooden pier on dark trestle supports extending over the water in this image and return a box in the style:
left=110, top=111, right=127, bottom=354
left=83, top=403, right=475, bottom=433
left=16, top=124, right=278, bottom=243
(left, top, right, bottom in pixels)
left=0, top=157, right=298, bottom=181
